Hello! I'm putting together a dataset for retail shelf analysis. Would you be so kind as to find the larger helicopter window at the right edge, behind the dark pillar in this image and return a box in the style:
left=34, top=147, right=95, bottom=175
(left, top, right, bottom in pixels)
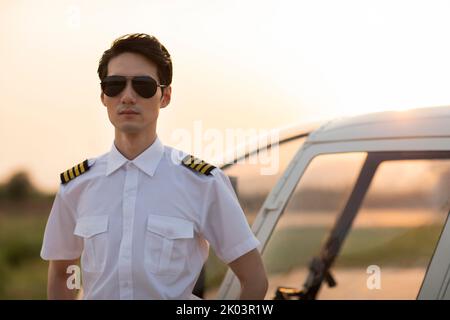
left=318, top=160, right=450, bottom=299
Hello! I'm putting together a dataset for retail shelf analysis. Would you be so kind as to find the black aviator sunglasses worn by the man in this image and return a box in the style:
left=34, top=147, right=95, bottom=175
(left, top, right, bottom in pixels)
left=100, top=76, right=167, bottom=99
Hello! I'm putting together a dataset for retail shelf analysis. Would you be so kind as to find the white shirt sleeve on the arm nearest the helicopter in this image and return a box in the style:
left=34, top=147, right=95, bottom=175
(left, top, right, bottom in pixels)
left=202, top=168, right=260, bottom=264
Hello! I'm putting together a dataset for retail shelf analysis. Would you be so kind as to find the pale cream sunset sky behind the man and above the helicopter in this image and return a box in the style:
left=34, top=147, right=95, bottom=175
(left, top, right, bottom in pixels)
left=0, top=0, right=450, bottom=191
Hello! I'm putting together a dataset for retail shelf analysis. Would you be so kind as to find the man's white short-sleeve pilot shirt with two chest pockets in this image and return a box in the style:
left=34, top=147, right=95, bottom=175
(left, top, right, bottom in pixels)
left=41, top=138, right=260, bottom=299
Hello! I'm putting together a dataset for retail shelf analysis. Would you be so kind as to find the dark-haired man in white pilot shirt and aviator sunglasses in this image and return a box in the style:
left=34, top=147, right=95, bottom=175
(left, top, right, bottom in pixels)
left=41, top=34, right=267, bottom=299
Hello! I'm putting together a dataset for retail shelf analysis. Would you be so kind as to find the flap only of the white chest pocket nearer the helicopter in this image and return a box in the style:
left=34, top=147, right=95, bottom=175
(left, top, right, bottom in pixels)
left=147, top=214, right=194, bottom=239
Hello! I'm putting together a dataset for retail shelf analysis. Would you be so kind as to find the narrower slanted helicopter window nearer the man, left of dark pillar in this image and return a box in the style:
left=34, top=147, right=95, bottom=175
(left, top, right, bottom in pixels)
left=263, top=152, right=367, bottom=299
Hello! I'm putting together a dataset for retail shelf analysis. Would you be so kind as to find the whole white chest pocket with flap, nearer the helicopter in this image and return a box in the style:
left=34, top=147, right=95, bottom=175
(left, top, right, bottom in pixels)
left=144, top=214, right=194, bottom=275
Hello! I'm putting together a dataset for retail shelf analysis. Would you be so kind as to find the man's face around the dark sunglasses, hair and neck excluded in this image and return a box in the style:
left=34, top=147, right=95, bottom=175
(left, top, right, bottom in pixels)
left=101, top=52, right=171, bottom=134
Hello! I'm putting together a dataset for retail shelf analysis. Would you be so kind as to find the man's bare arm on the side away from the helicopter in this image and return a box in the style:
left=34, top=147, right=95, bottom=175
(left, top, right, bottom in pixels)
left=47, top=259, right=79, bottom=300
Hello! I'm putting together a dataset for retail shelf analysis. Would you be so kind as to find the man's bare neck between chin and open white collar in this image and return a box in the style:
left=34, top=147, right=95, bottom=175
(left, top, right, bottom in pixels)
left=114, top=131, right=156, bottom=160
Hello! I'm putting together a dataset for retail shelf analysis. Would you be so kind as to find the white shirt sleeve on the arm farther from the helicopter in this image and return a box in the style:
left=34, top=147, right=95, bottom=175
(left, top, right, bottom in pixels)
left=41, top=188, right=83, bottom=260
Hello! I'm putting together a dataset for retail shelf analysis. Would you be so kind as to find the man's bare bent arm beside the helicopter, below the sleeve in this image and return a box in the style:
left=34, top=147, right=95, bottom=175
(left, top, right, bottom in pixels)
left=229, top=249, right=268, bottom=300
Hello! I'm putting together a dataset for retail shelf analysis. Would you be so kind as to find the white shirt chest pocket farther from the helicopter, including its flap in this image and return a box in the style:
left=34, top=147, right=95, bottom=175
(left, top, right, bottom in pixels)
left=74, top=216, right=108, bottom=272
